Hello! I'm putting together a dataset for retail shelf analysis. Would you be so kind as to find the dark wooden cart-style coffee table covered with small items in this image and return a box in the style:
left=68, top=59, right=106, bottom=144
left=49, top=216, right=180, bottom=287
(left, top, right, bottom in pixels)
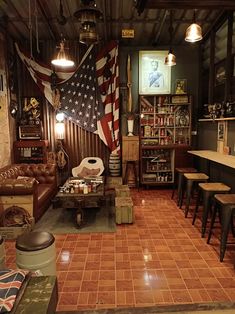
left=53, top=177, right=105, bottom=227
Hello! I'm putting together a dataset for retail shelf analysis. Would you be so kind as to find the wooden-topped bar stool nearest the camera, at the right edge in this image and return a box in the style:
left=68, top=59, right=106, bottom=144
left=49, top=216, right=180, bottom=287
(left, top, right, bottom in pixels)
left=207, top=194, right=235, bottom=262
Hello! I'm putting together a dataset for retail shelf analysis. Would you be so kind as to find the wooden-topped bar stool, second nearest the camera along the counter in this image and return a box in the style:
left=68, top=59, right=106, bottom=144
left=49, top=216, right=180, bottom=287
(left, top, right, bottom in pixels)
left=192, top=182, right=231, bottom=238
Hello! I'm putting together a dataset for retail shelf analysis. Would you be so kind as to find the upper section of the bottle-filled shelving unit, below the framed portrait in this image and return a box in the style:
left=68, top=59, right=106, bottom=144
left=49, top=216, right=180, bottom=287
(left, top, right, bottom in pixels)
left=140, top=95, right=191, bottom=145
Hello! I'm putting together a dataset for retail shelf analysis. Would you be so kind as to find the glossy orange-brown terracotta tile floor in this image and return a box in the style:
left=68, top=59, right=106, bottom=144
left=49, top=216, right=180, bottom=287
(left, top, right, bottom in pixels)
left=3, top=189, right=235, bottom=311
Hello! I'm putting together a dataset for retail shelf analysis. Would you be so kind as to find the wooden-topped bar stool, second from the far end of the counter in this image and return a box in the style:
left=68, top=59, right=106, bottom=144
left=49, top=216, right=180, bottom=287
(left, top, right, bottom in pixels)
left=181, top=172, right=209, bottom=218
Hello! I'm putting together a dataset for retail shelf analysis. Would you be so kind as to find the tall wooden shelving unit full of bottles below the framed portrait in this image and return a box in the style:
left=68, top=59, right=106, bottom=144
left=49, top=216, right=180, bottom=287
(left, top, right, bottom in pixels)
left=140, top=95, right=192, bottom=185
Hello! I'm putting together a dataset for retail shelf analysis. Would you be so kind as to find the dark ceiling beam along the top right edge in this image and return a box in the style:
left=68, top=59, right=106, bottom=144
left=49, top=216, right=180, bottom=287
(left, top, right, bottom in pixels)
left=148, top=0, right=235, bottom=10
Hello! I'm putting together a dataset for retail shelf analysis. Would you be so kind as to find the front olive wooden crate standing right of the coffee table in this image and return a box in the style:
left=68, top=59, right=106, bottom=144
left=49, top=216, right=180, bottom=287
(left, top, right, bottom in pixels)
left=115, top=196, right=133, bottom=224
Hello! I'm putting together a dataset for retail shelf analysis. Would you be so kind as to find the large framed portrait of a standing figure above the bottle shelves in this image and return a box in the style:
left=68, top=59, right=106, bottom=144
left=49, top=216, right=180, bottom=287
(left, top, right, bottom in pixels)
left=139, top=50, right=171, bottom=95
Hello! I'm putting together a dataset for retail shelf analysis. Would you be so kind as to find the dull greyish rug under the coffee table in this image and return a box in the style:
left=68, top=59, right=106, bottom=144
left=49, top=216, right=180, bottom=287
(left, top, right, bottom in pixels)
left=34, top=205, right=116, bottom=234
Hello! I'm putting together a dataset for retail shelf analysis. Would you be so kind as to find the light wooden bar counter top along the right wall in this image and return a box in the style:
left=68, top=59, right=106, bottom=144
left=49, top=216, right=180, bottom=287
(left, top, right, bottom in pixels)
left=188, top=150, right=235, bottom=169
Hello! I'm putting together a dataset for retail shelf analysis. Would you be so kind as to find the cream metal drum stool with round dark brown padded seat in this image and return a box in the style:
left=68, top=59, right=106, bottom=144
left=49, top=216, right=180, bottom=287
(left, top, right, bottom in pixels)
left=16, top=232, right=56, bottom=276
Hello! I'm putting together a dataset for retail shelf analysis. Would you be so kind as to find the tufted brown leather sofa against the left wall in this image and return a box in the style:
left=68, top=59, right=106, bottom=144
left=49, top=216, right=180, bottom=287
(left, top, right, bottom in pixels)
left=0, top=164, right=57, bottom=221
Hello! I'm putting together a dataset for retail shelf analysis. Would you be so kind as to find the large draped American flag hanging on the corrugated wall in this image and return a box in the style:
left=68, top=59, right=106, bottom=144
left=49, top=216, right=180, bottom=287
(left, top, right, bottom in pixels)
left=16, top=41, right=120, bottom=153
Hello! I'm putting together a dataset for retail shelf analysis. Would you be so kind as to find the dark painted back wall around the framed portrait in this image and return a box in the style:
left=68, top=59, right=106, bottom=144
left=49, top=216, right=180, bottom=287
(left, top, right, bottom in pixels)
left=119, top=44, right=199, bottom=146
